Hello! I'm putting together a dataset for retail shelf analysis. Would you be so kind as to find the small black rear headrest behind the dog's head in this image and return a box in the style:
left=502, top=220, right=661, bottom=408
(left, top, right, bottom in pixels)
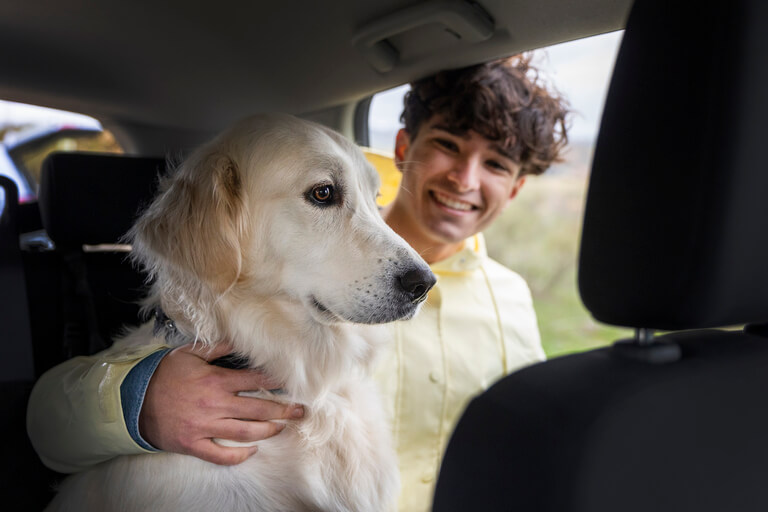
left=39, top=153, right=165, bottom=247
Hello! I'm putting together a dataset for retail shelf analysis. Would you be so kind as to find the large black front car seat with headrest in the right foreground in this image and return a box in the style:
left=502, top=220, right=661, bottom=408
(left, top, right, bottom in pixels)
left=434, top=0, right=768, bottom=512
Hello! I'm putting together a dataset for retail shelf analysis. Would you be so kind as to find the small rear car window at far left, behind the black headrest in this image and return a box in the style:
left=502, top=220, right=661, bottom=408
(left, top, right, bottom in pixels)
left=0, top=101, right=123, bottom=203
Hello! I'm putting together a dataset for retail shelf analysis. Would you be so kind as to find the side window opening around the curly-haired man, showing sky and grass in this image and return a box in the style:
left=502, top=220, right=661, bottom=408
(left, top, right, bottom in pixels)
left=368, top=31, right=631, bottom=357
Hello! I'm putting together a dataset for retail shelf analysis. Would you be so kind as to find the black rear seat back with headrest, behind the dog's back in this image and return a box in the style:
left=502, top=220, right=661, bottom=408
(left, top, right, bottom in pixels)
left=31, top=153, right=165, bottom=373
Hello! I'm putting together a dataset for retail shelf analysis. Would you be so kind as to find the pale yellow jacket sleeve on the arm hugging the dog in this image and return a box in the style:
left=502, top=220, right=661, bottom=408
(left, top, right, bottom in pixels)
left=27, top=344, right=168, bottom=473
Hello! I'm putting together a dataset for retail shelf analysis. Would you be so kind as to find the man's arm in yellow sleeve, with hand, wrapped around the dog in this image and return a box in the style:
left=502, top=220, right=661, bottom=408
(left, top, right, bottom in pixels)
left=27, top=338, right=303, bottom=473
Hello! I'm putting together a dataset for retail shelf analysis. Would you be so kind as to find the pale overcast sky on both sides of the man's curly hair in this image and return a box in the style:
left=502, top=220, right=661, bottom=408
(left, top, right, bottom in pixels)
left=370, top=31, right=623, bottom=150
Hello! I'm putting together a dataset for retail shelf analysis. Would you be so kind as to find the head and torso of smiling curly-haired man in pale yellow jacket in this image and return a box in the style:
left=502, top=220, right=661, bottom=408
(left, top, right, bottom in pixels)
left=377, top=57, right=567, bottom=512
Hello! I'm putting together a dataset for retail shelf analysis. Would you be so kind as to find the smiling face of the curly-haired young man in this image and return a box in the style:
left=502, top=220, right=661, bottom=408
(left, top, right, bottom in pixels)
left=388, top=116, right=525, bottom=261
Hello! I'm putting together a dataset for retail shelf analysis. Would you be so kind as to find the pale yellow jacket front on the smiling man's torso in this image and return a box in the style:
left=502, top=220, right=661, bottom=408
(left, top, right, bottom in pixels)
left=376, top=235, right=545, bottom=512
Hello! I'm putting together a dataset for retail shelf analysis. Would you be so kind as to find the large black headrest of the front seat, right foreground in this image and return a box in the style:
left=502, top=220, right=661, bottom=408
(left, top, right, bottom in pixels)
left=579, top=0, right=768, bottom=330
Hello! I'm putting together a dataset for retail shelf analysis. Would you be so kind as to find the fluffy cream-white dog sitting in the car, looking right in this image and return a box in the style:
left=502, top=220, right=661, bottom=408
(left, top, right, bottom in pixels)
left=45, top=115, right=435, bottom=512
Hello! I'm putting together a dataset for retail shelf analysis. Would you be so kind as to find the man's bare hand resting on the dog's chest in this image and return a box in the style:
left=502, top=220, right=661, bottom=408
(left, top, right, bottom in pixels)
left=139, top=344, right=304, bottom=465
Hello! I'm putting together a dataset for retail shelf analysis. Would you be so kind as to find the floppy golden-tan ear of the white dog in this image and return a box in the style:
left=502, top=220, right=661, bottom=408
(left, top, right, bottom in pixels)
left=131, top=152, right=245, bottom=294
